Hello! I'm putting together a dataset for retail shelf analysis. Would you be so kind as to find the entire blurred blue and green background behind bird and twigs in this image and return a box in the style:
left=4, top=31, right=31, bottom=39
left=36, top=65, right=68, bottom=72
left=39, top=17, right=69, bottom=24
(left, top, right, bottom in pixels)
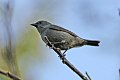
left=0, top=0, right=120, bottom=80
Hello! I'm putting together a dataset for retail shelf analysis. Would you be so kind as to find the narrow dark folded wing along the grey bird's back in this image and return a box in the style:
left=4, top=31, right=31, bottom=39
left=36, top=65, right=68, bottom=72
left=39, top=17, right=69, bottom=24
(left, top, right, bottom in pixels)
left=49, top=25, right=78, bottom=37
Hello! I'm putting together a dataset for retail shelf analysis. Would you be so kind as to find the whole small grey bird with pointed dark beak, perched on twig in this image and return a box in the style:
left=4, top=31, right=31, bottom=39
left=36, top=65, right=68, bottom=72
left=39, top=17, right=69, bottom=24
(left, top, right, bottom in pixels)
left=31, top=21, right=100, bottom=53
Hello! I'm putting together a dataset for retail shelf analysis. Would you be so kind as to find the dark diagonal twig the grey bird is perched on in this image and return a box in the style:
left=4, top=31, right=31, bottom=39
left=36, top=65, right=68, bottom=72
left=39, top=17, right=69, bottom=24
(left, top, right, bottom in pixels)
left=45, top=37, right=89, bottom=80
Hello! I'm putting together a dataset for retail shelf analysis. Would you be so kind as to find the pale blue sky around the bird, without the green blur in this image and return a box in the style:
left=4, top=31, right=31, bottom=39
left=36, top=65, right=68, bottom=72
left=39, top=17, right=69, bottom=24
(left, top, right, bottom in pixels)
left=0, top=0, right=120, bottom=80
